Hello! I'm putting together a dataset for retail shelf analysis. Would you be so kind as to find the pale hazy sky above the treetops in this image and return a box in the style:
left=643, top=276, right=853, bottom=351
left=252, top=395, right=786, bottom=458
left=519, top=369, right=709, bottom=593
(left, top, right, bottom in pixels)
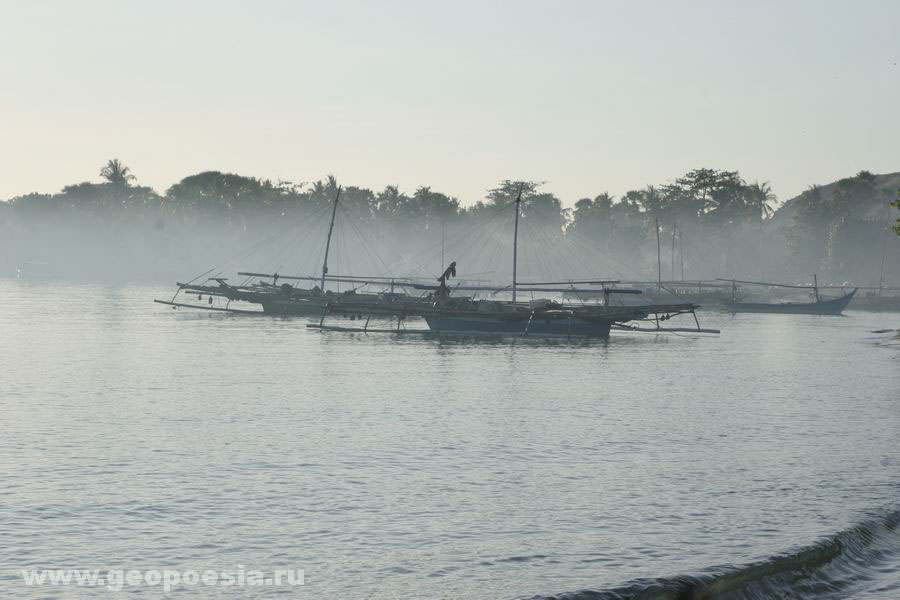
left=0, top=0, right=900, bottom=205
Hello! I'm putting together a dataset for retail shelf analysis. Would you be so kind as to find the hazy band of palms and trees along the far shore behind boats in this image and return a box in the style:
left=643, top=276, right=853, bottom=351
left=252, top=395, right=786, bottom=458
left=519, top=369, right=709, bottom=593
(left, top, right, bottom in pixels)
left=0, top=160, right=900, bottom=285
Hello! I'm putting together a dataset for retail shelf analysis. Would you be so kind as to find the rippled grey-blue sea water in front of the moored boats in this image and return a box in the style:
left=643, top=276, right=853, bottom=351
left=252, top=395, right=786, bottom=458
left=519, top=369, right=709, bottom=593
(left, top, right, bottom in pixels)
left=0, top=280, right=900, bottom=599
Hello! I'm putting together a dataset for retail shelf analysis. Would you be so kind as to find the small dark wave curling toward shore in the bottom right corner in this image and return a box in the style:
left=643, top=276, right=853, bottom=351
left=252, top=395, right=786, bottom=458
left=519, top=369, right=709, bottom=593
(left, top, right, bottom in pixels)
left=531, top=509, right=900, bottom=600
